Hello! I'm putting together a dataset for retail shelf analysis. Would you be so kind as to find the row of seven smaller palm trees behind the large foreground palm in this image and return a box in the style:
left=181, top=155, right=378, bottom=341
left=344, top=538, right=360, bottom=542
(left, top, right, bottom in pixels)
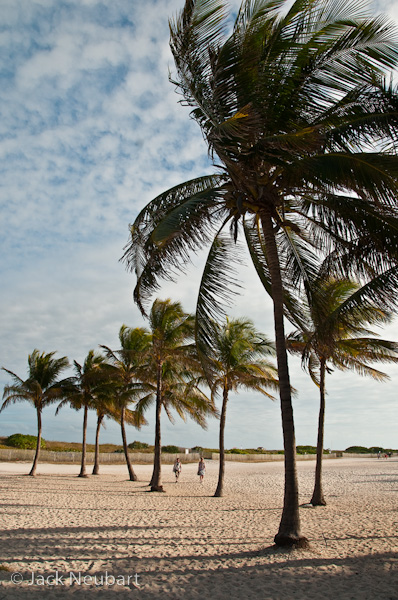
left=0, top=275, right=398, bottom=506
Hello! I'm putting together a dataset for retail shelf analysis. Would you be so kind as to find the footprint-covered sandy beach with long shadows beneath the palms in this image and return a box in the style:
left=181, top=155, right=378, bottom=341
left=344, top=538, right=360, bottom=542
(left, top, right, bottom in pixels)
left=0, top=458, right=398, bottom=600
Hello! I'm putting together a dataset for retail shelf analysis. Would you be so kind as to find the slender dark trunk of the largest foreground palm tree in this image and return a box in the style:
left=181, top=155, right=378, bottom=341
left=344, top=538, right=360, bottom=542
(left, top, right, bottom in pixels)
left=262, top=212, right=307, bottom=546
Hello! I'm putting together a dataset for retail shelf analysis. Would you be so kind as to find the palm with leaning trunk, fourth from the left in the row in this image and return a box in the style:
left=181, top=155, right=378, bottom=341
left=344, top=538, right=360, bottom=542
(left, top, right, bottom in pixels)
left=101, top=325, right=151, bottom=481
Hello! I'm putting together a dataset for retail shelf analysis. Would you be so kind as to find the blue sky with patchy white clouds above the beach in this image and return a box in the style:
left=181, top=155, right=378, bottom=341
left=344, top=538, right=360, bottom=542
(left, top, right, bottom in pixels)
left=0, top=0, right=398, bottom=449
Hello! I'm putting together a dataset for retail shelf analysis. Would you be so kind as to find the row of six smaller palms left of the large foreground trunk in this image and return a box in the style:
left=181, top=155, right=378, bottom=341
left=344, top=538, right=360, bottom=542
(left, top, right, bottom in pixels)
left=0, top=299, right=277, bottom=496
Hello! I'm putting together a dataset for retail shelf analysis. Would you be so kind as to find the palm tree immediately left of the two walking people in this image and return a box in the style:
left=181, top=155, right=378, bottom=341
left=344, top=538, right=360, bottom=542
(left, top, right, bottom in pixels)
left=137, top=299, right=215, bottom=492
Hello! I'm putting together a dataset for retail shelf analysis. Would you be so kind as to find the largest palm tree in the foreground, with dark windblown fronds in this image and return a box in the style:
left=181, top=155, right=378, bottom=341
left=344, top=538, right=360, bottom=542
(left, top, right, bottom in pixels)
left=124, top=0, right=398, bottom=545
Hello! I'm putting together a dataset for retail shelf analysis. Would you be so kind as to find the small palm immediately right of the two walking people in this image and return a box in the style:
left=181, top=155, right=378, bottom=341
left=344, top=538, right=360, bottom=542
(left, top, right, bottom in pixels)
left=211, top=318, right=278, bottom=497
